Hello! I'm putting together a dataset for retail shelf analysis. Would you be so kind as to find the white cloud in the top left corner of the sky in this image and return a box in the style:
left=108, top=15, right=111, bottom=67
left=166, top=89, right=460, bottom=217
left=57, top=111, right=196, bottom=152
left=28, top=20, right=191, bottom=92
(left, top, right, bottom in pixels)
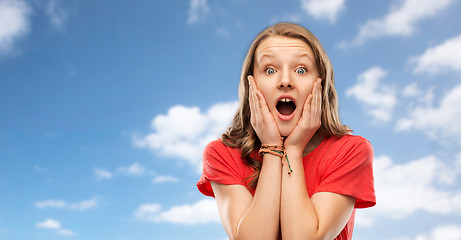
left=0, top=0, right=32, bottom=55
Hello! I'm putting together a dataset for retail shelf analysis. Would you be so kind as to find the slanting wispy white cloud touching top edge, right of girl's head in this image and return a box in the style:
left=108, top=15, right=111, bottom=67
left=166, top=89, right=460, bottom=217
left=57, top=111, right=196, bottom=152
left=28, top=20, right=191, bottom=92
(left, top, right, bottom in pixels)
left=340, top=0, right=454, bottom=47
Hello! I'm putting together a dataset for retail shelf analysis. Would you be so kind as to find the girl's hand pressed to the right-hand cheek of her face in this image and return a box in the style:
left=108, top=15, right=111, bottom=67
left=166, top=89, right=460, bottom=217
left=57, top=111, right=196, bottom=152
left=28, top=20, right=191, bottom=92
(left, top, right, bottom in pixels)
left=285, top=78, right=322, bottom=152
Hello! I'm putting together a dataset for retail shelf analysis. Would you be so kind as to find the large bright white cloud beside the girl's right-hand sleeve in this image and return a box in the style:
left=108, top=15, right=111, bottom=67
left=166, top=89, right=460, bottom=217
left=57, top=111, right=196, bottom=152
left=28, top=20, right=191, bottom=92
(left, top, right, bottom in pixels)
left=357, top=156, right=461, bottom=226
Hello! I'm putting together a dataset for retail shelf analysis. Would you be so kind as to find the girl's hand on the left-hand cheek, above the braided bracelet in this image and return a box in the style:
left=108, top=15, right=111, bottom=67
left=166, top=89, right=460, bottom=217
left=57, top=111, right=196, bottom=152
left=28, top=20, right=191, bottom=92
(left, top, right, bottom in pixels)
left=248, top=76, right=283, bottom=145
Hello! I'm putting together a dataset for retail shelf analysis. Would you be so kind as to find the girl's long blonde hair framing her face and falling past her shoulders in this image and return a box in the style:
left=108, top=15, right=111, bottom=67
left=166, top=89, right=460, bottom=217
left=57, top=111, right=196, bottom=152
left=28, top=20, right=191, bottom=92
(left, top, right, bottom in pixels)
left=222, top=23, right=351, bottom=188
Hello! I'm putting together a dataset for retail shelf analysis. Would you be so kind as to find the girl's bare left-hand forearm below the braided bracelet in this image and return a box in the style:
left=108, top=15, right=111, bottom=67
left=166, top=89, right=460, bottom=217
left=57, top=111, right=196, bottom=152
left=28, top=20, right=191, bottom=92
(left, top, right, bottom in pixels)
left=236, top=154, right=282, bottom=240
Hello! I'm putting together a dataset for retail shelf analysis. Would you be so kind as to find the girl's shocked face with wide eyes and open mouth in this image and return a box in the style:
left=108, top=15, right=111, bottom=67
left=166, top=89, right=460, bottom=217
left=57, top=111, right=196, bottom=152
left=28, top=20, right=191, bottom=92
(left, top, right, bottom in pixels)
left=253, top=36, right=319, bottom=137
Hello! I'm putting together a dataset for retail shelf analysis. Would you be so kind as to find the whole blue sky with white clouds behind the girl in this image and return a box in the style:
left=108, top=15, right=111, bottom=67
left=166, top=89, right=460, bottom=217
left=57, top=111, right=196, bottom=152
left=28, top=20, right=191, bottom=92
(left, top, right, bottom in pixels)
left=0, top=0, right=461, bottom=240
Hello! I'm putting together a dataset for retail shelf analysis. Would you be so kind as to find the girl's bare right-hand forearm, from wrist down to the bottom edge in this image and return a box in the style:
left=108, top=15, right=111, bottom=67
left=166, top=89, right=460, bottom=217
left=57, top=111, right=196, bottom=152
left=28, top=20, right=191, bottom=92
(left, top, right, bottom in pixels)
left=280, top=150, right=322, bottom=239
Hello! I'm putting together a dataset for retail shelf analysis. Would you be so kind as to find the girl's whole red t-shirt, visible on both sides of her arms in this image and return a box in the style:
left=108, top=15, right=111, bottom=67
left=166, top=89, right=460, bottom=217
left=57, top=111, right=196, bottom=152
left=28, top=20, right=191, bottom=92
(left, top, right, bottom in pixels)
left=197, top=135, right=376, bottom=240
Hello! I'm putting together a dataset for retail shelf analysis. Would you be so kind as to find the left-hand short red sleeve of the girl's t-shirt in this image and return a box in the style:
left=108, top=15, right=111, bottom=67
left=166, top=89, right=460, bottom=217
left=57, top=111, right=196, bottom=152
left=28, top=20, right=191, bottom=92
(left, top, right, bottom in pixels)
left=197, top=140, right=245, bottom=197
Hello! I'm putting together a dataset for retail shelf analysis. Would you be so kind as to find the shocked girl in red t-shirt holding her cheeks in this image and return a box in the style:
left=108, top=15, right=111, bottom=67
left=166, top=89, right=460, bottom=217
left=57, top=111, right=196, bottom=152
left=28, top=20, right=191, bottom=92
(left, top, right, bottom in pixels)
left=197, top=23, right=376, bottom=240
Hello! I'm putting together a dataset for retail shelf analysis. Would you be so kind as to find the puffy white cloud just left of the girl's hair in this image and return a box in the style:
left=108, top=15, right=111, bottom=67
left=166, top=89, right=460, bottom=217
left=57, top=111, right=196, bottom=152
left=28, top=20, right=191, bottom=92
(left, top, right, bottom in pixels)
left=133, top=102, right=237, bottom=171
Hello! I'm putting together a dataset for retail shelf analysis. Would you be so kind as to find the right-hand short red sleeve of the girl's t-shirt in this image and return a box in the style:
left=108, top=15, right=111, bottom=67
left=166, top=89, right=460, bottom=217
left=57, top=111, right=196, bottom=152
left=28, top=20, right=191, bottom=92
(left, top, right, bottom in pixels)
left=315, top=137, right=376, bottom=208
